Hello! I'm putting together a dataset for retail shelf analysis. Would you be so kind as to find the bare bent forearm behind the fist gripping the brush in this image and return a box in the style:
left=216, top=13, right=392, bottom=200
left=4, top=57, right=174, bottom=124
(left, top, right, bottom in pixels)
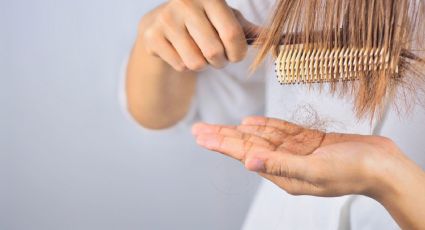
left=126, top=31, right=196, bottom=129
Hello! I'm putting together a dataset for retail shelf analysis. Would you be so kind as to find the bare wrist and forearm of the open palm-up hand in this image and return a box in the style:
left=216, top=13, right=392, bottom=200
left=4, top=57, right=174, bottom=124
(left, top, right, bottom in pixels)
left=377, top=155, right=425, bottom=229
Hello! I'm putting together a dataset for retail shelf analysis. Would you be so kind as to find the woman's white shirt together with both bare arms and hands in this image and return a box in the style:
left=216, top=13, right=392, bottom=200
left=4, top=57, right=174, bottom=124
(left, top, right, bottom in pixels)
left=127, top=0, right=425, bottom=229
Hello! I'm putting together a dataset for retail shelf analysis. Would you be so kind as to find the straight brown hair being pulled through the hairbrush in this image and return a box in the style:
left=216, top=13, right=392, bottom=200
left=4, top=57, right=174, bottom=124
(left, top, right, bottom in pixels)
left=253, top=0, right=425, bottom=118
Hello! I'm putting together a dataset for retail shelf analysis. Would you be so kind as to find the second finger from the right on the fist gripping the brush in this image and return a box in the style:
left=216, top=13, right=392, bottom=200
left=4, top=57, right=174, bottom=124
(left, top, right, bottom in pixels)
left=186, top=7, right=227, bottom=68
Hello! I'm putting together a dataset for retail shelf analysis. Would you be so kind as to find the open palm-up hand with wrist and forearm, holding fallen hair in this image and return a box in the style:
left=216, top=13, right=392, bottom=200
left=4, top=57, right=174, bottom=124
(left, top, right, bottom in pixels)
left=193, top=117, right=425, bottom=229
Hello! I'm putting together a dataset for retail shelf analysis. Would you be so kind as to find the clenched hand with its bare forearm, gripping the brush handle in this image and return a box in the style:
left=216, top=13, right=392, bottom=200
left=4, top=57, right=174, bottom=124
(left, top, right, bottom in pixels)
left=126, top=0, right=260, bottom=129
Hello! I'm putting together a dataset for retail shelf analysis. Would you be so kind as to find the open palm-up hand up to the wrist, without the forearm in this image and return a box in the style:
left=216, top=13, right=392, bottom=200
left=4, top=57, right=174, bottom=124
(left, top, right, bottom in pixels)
left=193, top=117, right=403, bottom=197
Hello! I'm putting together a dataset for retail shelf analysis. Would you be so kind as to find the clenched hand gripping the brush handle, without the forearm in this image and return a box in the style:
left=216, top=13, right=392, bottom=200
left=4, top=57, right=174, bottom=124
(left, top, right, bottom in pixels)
left=139, top=0, right=255, bottom=71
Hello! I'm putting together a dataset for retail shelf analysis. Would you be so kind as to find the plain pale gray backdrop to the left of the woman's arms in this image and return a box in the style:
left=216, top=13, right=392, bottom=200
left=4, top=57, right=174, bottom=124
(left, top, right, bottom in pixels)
left=0, top=0, right=258, bottom=230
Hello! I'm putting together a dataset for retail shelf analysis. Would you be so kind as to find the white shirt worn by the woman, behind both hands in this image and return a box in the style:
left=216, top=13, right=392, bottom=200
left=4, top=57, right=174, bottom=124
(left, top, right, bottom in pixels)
left=122, top=0, right=425, bottom=230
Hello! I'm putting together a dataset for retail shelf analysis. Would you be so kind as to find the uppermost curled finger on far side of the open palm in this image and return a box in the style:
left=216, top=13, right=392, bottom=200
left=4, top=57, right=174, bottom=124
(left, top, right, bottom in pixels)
left=242, top=116, right=304, bottom=135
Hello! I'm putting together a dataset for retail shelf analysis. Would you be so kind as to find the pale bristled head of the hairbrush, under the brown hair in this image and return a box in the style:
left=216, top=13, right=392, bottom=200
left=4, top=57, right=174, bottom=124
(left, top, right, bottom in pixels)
left=275, top=44, right=398, bottom=84
